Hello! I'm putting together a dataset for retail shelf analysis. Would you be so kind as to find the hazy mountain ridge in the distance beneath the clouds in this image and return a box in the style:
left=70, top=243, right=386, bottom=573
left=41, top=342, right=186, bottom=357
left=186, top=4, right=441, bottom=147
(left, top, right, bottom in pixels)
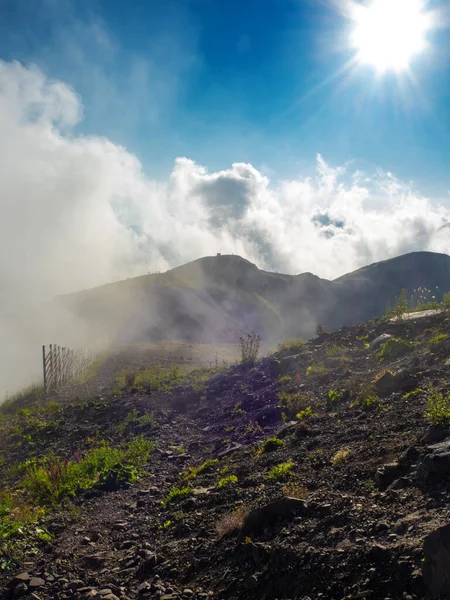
left=57, top=252, right=450, bottom=345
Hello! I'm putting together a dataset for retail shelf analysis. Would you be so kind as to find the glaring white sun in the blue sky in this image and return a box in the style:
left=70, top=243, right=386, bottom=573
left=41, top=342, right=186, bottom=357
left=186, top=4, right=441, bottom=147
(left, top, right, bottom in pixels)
left=351, top=0, right=431, bottom=72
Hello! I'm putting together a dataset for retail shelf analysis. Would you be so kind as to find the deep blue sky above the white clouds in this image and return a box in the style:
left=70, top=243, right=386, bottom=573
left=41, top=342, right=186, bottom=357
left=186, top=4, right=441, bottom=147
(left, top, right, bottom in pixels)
left=0, top=0, right=450, bottom=199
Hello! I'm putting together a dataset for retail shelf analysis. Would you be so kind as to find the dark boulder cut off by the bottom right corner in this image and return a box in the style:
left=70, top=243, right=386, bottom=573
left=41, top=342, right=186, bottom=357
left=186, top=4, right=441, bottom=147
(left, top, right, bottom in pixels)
left=423, top=524, right=450, bottom=598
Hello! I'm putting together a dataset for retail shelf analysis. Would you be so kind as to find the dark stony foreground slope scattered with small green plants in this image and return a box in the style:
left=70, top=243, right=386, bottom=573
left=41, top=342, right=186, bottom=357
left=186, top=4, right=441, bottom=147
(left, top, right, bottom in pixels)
left=0, top=313, right=450, bottom=600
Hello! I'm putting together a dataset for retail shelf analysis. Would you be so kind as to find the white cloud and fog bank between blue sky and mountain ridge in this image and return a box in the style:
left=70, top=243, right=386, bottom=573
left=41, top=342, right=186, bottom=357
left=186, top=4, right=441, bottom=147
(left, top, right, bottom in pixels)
left=0, top=61, right=450, bottom=397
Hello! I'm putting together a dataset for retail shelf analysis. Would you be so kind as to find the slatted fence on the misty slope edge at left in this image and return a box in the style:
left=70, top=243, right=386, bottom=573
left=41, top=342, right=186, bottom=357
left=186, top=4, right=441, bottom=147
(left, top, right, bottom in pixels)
left=42, top=344, right=98, bottom=393
